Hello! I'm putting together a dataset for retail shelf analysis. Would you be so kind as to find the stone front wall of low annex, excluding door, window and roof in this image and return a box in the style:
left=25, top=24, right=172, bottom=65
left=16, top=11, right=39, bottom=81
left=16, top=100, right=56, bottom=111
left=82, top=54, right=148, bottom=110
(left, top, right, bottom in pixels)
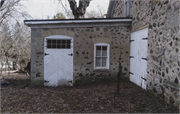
left=31, top=27, right=130, bottom=84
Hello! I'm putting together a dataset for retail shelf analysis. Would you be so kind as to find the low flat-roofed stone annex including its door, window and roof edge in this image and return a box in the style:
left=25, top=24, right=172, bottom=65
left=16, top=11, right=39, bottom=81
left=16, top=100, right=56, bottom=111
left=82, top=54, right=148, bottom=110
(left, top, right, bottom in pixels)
left=25, top=18, right=132, bottom=86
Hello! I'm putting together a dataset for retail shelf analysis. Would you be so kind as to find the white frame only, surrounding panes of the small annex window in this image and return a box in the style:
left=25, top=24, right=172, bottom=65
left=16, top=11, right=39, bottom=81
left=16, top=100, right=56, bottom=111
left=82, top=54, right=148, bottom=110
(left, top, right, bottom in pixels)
left=94, top=43, right=110, bottom=69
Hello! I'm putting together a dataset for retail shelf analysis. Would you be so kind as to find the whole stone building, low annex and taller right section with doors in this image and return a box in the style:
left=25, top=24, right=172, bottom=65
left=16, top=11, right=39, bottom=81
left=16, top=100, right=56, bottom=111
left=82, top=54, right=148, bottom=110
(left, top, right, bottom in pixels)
left=25, top=0, right=180, bottom=106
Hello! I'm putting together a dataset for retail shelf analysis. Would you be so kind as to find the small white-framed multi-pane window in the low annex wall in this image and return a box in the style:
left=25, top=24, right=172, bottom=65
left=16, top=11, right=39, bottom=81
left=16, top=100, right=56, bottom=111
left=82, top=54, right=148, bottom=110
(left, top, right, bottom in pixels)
left=94, top=43, right=109, bottom=69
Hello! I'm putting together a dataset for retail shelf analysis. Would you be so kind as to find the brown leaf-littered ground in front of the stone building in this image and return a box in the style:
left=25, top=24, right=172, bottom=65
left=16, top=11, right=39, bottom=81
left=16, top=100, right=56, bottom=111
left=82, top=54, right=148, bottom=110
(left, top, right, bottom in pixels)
left=1, top=72, right=179, bottom=113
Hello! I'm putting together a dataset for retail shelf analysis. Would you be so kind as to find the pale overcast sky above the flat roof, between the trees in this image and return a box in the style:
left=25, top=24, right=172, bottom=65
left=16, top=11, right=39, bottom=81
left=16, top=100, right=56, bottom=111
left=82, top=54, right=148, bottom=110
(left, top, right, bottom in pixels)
left=21, top=0, right=109, bottom=19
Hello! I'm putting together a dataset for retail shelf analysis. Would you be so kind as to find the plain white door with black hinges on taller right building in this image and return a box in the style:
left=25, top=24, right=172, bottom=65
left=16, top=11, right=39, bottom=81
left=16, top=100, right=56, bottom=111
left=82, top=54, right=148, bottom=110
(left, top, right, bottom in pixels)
left=130, top=28, right=148, bottom=89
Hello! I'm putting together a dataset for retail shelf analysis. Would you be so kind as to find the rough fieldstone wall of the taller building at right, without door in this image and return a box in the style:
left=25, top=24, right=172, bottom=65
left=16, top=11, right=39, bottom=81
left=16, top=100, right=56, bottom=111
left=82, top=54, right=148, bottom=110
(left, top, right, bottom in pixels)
left=114, top=0, right=180, bottom=106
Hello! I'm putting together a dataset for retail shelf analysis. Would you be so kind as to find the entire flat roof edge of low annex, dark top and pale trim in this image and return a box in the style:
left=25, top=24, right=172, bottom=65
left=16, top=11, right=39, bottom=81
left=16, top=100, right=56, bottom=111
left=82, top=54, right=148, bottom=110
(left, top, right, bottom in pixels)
left=24, top=18, right=132, bottom=28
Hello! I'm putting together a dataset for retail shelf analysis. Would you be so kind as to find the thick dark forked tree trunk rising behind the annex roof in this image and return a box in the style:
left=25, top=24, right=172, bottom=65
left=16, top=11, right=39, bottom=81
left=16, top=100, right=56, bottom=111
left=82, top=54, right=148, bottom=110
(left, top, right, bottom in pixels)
left=68, top=0, right=91, bottom=19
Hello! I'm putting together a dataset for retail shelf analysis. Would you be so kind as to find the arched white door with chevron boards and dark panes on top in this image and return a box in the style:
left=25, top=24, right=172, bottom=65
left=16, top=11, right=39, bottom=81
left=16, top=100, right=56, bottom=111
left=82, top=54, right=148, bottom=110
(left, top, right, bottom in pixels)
left=44, top=35, right=73, bottom=86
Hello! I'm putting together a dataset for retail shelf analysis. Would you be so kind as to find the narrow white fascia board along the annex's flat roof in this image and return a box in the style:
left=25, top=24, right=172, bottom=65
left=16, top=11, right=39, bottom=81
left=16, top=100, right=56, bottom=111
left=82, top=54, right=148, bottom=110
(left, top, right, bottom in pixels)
left=25, top=19, right=132, bottom=25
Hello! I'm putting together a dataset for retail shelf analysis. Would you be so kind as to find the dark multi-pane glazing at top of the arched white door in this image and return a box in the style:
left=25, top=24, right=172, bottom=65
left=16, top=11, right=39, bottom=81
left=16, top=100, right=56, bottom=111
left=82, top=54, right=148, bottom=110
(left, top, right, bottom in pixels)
left=47, top=39, right=71, bottom=49
